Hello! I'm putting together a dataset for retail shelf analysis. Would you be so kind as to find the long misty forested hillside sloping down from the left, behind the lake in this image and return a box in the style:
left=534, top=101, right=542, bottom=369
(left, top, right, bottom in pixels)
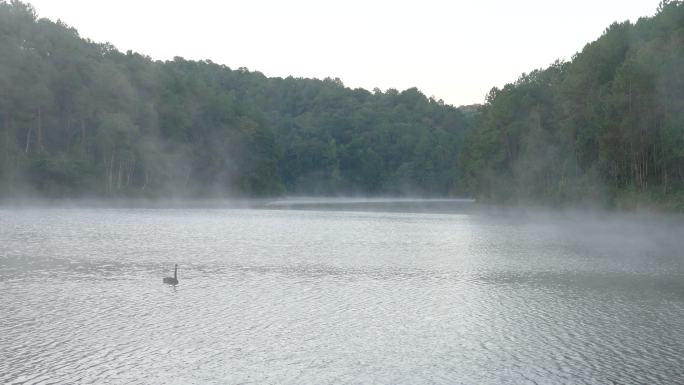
left=0, top=1, right=471, bottom=197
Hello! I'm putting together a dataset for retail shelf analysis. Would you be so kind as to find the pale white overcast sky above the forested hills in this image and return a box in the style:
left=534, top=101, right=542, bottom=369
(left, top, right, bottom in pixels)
left=28, top=0, right=660, bottom=105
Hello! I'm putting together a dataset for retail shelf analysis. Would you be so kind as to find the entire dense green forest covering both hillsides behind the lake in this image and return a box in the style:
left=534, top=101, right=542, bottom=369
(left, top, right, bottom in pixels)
left=0, top=0, right=684, bottom=209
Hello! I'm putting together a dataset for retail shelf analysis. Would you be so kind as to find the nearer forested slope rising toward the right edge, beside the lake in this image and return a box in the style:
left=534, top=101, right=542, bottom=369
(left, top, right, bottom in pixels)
left=461, top=1, right=684, bottom=208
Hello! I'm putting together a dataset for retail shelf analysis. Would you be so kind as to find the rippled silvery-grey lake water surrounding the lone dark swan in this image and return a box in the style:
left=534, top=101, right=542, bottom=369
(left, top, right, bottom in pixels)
left=0, top=200, right=684, bottom=384
